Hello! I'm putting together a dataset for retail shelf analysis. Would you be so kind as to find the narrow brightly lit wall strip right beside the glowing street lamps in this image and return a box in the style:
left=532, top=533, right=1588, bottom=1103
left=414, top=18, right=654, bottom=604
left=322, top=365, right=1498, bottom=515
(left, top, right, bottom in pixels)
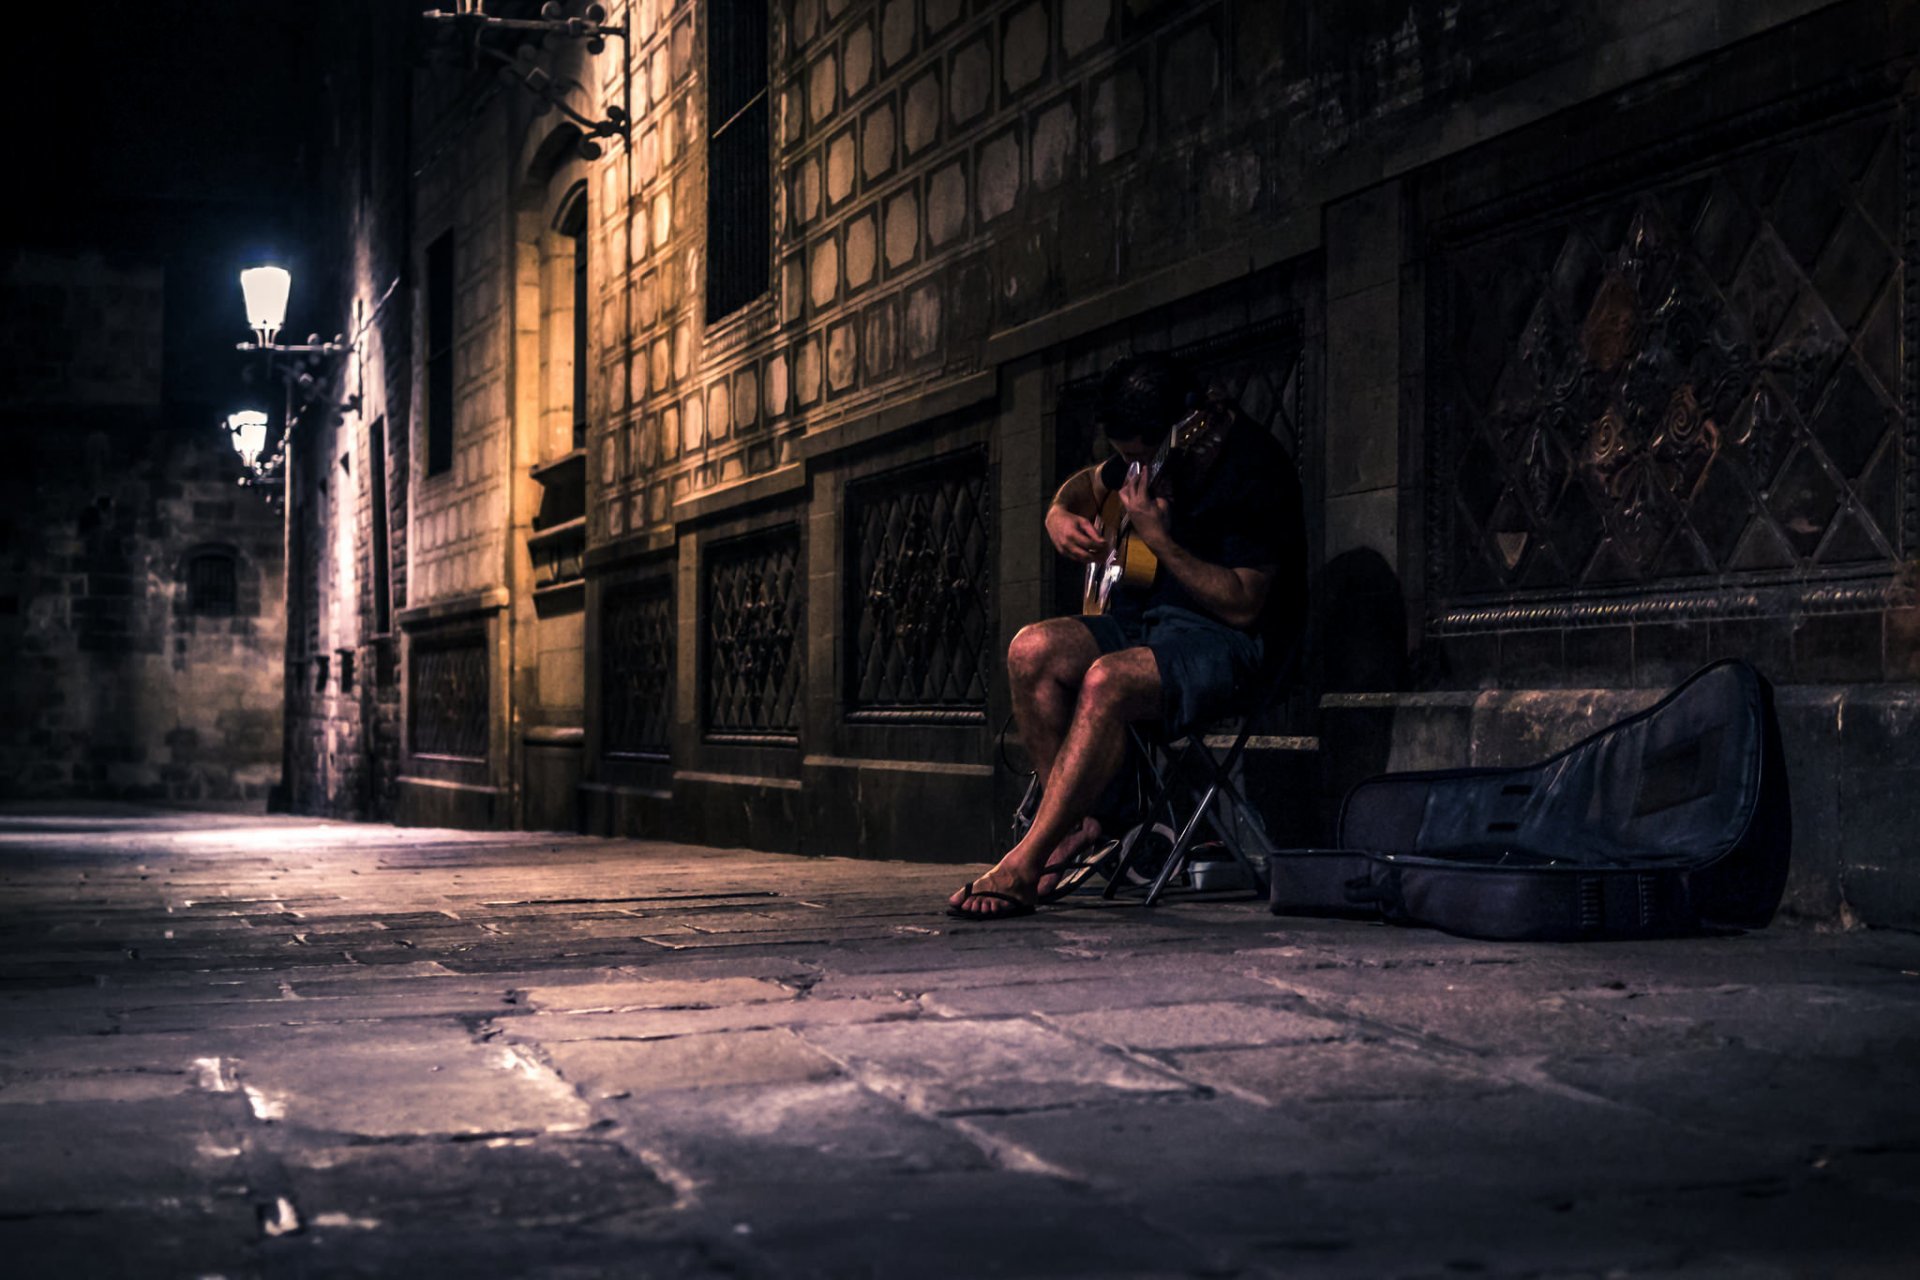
left=284, top=4, right=415, bottom=819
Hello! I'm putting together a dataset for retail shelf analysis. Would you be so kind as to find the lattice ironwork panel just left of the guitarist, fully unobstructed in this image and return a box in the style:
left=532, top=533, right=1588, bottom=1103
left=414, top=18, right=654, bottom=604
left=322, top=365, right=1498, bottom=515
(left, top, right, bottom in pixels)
left=847, top=449, right=993, bottom=722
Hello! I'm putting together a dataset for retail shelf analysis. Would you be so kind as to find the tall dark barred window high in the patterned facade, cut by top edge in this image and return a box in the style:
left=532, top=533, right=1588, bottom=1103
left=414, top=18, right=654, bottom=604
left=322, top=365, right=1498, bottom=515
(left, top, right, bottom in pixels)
left=707, top=0, right=774, bottom=324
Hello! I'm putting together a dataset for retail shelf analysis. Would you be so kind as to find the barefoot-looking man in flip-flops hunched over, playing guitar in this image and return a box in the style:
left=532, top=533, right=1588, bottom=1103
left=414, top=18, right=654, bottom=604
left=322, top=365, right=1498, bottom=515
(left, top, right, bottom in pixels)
left=948, top=353, right=1306, bottom=921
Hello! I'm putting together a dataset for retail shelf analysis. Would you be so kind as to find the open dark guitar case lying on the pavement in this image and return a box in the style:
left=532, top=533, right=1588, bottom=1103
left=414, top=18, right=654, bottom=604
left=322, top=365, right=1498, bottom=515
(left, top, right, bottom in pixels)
left=1267, top=660, right=1793, bottom=940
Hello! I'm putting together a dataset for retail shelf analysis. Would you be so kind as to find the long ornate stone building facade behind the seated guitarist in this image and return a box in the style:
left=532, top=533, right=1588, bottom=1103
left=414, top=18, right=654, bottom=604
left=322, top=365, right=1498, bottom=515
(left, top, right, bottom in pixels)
left=290, top=0, right=1920, bottom=921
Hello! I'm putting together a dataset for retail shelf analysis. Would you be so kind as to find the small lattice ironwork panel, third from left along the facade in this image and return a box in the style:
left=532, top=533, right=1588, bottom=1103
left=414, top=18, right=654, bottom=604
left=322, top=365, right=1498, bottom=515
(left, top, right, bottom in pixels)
left=705, top=526, right=806, bottom=741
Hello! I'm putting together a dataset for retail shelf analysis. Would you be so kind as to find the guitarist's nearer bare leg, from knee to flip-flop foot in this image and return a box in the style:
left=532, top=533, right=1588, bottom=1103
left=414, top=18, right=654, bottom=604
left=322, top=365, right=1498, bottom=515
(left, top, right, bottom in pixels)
left=948, top=647, right=1160, bottom=917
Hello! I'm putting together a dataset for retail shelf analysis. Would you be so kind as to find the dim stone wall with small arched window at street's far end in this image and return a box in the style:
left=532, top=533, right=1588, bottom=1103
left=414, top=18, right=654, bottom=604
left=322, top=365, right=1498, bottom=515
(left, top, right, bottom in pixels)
left=0, top=251, right=282, bottom=806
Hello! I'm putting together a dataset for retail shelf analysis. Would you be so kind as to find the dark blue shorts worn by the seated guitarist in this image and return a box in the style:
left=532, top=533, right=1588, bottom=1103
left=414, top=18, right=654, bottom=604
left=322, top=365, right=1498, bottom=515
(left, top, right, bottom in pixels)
left=1081, top=604, right=1263, bottom=737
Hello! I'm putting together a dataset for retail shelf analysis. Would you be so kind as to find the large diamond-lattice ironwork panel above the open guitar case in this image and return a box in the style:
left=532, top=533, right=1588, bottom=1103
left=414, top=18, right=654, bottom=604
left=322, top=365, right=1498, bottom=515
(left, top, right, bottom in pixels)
left=1428, top=109, right=1914, bottom=628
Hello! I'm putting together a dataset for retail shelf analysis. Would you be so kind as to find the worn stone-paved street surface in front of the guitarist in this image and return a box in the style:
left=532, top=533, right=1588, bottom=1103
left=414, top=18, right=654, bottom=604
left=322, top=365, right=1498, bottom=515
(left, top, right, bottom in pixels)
left=0, top=810, right=1920, bottom=1280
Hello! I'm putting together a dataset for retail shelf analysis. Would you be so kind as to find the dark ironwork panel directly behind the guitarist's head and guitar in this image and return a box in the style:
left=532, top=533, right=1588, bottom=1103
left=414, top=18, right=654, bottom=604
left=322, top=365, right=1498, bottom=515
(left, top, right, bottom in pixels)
left=1054, top=311, right=1309, bottom=614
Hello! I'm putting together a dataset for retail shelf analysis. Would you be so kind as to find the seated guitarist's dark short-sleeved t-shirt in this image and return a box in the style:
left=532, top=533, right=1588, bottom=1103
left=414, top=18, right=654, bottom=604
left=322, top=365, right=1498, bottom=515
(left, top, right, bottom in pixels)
left=1100, top=413, right=1308, bottom=644
